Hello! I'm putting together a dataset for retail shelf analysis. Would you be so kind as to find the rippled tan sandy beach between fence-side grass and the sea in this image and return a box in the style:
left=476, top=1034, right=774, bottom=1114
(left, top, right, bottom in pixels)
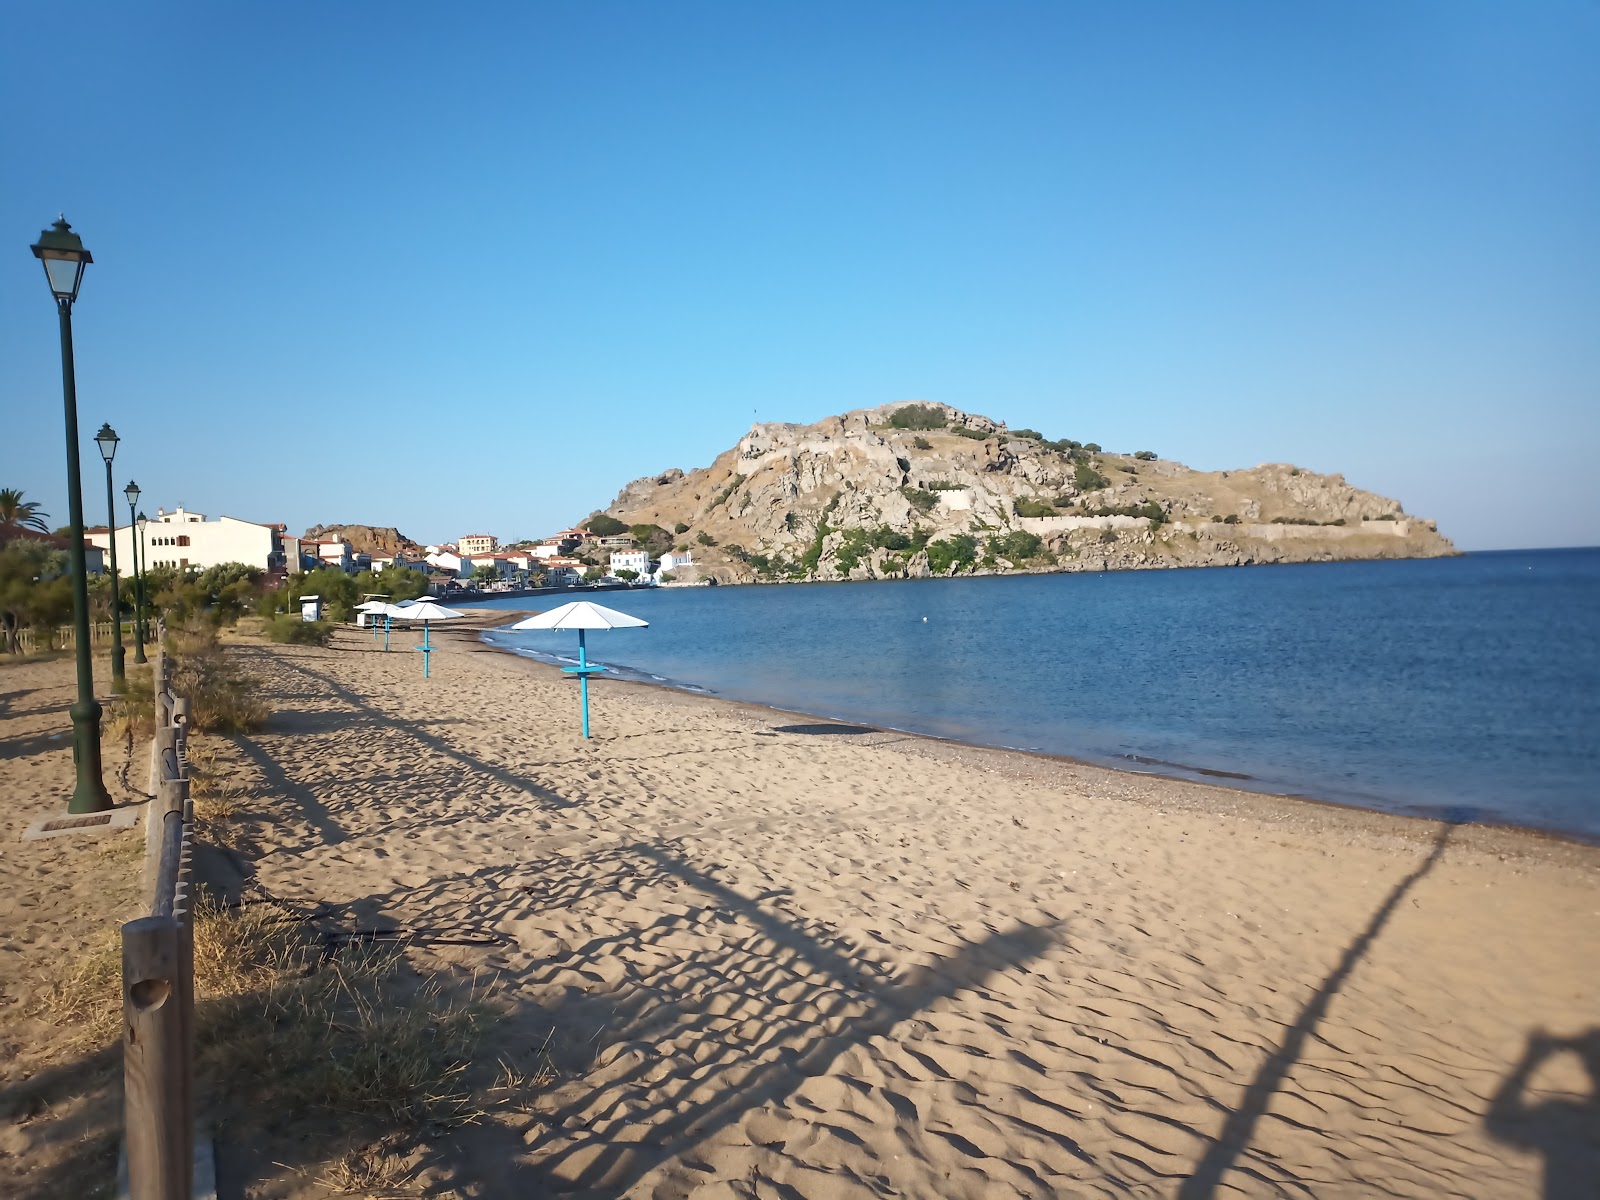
left=6, top=614, right=1600, bottom=1200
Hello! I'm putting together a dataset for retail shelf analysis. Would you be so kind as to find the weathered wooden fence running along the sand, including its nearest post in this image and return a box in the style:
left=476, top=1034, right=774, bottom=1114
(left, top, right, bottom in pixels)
left=122, top=633, right=195, bottom=1200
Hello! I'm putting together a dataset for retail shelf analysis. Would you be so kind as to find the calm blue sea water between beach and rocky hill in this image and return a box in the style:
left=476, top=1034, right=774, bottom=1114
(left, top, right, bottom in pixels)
left=470, top=549, right=1600, bottom=842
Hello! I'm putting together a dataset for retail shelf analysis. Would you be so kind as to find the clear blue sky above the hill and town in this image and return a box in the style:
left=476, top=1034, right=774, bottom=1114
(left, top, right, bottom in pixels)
left=0, top=0, right=1600, bottom=549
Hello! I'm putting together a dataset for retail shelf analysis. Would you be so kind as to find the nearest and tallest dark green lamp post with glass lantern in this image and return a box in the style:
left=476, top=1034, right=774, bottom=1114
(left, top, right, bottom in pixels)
left=32, top=218, right=112, bottom=813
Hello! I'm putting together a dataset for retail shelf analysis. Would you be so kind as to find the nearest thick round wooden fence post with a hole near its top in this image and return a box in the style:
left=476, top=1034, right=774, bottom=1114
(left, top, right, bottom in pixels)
left=122, top=917, right=194, bottom=1200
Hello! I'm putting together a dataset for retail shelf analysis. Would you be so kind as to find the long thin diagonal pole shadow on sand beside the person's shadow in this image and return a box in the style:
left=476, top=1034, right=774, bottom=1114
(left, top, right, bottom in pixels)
left=1178, top=826, right=1451, bottom=1200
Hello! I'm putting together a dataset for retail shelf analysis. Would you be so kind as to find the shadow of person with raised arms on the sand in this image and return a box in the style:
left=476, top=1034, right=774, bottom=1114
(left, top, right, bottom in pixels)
left=1485, top=1026, right=1600, bottom=1200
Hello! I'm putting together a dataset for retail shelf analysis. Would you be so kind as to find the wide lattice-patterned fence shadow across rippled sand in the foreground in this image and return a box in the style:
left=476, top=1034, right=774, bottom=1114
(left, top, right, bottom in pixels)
left=316, top=843, right=1062, bottom=1197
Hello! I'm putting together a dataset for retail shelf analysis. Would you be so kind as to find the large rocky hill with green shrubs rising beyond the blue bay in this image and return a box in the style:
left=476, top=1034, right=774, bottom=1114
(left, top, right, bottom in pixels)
left=590, top=402, right=1456, bottom=582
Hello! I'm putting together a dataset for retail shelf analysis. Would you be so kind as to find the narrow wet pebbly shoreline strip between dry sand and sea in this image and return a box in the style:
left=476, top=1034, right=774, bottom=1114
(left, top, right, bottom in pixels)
left=464, top=614, right=1600, bottom=853
